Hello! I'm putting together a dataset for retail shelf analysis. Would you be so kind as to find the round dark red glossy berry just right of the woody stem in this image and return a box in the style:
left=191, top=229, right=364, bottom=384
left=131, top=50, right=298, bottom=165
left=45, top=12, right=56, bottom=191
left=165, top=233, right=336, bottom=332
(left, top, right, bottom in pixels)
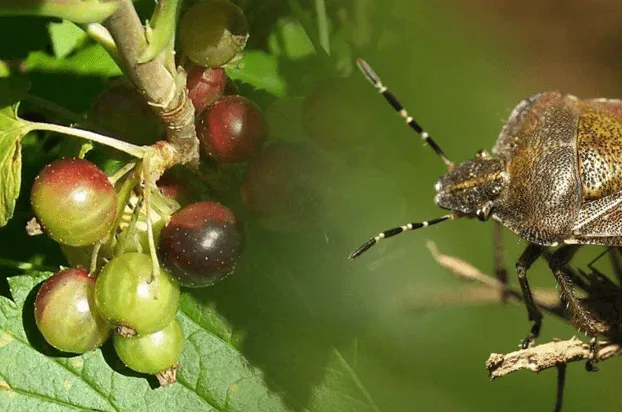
left=197, top=96, right=267, bottom=163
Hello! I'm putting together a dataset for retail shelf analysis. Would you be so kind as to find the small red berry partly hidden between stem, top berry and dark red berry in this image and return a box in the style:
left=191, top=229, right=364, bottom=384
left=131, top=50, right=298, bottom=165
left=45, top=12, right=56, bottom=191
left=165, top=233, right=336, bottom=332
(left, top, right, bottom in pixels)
left=186, top=65, right=227, bottom=113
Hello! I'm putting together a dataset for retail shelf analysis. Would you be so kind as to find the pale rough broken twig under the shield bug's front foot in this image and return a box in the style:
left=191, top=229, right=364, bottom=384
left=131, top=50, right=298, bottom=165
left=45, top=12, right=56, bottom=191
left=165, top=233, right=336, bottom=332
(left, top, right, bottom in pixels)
left=486, top=337, right=622, bottom=379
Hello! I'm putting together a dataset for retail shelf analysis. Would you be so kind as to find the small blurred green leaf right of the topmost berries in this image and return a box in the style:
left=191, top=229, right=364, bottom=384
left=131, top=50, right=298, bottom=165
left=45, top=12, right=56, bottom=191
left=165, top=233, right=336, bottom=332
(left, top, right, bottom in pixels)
left=227, top=50, right=285, bottom=97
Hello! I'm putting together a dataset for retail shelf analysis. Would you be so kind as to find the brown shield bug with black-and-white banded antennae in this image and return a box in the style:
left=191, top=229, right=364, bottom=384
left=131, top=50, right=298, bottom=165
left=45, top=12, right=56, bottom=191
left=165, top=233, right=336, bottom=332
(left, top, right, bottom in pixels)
left=350, top=59, right=622, bottom=369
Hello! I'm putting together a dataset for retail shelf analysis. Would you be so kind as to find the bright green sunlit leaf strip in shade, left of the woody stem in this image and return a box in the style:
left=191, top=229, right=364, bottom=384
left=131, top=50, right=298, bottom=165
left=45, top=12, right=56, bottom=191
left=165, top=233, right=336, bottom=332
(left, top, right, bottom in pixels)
left=24, top=44, right=122, bottom=77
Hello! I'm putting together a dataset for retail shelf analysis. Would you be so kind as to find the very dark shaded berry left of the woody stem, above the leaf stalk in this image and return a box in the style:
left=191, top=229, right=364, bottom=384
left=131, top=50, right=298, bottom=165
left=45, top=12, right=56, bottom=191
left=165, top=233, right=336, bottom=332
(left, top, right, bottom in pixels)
left=88, top=84, right=162, bottom=146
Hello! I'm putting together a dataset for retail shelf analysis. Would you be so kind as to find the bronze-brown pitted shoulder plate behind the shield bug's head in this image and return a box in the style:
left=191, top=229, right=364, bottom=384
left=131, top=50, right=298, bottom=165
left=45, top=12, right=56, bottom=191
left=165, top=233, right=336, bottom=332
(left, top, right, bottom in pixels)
left=493, top=92, right=582, bottom=246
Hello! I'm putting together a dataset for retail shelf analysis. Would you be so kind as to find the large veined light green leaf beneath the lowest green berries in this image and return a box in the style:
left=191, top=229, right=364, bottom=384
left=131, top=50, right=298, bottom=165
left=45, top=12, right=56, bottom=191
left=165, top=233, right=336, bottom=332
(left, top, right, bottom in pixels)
left=0, top=272, right=288, bottom=412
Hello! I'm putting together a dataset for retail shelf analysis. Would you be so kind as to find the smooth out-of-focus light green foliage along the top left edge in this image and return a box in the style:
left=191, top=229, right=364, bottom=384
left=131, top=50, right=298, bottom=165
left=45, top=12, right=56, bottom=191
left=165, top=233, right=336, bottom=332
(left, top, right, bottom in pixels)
left=0, top=0, right=118, bottom=23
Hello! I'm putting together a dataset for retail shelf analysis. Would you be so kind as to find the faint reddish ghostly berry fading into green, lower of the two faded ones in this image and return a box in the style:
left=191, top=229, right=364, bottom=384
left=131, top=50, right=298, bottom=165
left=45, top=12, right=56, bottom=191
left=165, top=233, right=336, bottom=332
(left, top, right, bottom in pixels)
left=242, top=143, right=327, bottom=232
